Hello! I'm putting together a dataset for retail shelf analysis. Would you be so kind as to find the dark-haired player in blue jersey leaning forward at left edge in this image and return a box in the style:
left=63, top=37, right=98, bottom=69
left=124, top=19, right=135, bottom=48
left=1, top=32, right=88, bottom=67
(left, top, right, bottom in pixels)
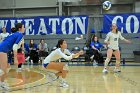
left=0, top=23, right=25, bottom=90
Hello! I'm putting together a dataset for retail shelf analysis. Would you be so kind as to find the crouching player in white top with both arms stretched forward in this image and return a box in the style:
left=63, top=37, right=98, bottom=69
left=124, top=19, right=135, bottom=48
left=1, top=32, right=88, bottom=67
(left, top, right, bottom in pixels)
left=44, top=39, right=83, bottom=87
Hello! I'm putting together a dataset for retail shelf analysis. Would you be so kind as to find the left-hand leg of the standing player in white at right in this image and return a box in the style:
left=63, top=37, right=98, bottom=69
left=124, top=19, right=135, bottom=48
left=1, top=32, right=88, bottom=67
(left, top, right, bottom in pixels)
left=102, top=49, right=113, bottom=73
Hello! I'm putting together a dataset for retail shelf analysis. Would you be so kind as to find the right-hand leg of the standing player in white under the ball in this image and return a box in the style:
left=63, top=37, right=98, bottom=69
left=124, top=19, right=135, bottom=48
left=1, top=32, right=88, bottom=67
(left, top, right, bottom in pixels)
left=114, top=49, right=121, bottom=72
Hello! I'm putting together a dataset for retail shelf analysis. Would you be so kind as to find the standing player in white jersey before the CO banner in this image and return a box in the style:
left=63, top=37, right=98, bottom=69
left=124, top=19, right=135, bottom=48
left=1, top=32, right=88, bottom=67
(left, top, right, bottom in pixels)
left=102, top=23, right=131, bottom=73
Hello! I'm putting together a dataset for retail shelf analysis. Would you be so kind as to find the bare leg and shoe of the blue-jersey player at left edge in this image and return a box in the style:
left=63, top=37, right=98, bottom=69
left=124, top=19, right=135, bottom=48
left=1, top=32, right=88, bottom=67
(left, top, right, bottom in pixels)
left=0, top=53, right=9, bottom=90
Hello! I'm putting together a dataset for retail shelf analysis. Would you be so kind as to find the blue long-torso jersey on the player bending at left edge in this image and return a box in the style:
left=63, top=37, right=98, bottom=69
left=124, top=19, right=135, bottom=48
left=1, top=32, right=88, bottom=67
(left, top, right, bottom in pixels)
left=0, top=32, right=23, bottom=53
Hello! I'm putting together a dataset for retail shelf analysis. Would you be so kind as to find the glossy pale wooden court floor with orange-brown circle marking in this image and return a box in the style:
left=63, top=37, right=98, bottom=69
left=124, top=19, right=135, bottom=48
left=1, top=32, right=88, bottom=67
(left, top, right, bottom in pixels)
left=0, top=66, right=140, bottom=93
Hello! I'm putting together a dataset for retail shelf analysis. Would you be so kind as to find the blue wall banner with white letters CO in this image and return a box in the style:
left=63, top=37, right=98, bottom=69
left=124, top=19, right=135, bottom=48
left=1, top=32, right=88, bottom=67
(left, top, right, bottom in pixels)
left=103, top=14, right=140, bottom=33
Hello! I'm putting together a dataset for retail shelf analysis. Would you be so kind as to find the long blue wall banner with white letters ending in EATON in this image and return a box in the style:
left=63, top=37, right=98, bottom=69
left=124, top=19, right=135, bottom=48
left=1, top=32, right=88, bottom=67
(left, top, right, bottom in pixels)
left=0, top=16, right=88, bottom=35
